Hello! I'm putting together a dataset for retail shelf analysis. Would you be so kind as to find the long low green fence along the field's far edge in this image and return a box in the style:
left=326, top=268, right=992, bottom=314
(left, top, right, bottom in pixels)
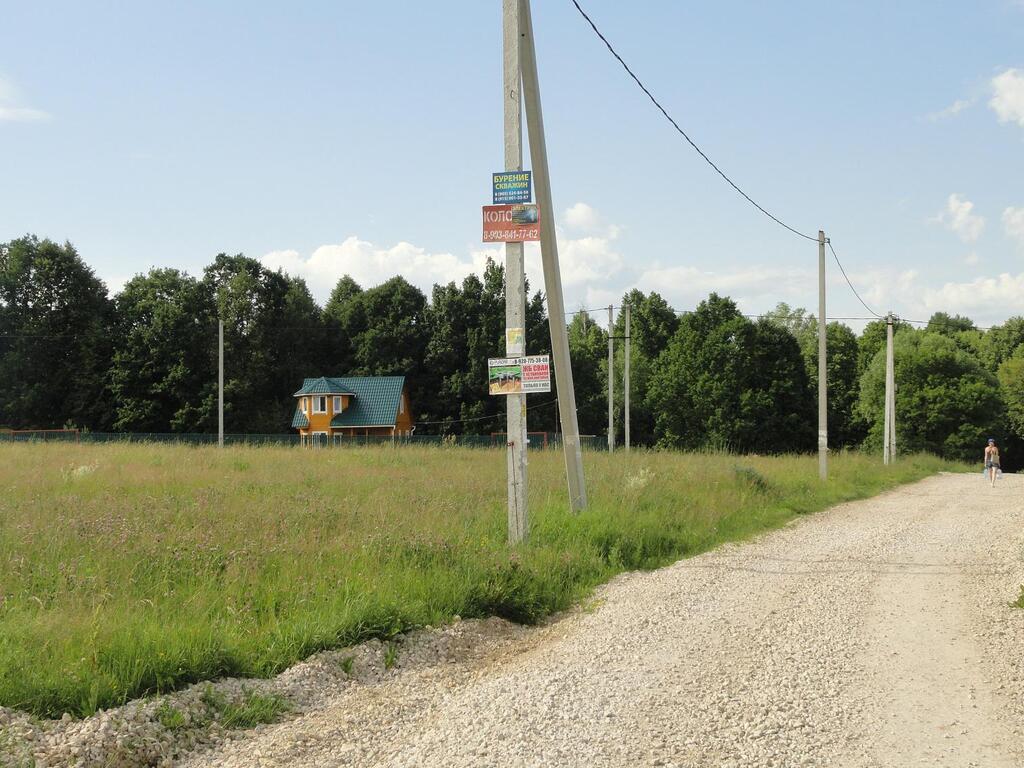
left=0, top=429, right=607, bottom=451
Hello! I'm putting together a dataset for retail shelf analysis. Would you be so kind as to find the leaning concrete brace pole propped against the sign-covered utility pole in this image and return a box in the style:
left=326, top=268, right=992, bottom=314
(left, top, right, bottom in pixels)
left=519, top=0, right=587, bottom=512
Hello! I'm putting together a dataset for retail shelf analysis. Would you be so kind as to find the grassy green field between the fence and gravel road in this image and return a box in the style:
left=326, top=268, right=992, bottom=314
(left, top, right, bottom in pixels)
left=0, top=444, right=950, bottom=717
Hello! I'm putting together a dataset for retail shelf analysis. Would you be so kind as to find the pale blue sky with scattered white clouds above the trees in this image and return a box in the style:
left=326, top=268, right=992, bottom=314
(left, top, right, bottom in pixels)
left=0, top=0, right=1024, bottom=327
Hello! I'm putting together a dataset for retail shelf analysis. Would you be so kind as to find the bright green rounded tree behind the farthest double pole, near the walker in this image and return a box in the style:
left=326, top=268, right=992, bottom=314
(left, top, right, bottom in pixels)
left=858, top=329, right=1002, bottom=461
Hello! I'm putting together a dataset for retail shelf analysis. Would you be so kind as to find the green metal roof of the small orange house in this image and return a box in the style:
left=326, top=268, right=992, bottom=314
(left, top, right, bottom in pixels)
left=292, top=376, right=406, bottom=429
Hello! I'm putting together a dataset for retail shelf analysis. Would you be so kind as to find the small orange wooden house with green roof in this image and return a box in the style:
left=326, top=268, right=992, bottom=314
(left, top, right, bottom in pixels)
left=292, top=376, right=416, bottom=443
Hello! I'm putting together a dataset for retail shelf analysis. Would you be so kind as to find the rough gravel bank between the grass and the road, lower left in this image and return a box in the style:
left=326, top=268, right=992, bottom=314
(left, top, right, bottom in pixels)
left=0, top=616, right=524, bottom=768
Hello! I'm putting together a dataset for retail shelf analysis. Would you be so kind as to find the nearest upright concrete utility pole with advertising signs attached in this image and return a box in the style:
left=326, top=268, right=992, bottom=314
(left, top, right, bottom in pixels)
left=502, top=0, right=527, bottom=544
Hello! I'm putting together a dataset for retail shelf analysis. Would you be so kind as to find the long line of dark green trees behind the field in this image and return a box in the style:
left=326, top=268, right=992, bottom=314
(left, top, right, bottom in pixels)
left=0, top=236, right=1024, bottom=465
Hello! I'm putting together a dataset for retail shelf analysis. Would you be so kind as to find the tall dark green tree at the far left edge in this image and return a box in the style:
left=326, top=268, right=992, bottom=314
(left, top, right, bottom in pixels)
left=0, top=236, right=114, bottom=429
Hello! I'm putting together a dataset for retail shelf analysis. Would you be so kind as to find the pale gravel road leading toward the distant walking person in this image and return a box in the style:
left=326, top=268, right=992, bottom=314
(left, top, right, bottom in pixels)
left=185, top=474, right=1024, bottom=768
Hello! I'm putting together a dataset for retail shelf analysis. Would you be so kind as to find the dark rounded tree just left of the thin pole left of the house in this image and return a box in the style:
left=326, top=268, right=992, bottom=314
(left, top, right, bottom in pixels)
left=109, top=269, right=217, bottom=432
